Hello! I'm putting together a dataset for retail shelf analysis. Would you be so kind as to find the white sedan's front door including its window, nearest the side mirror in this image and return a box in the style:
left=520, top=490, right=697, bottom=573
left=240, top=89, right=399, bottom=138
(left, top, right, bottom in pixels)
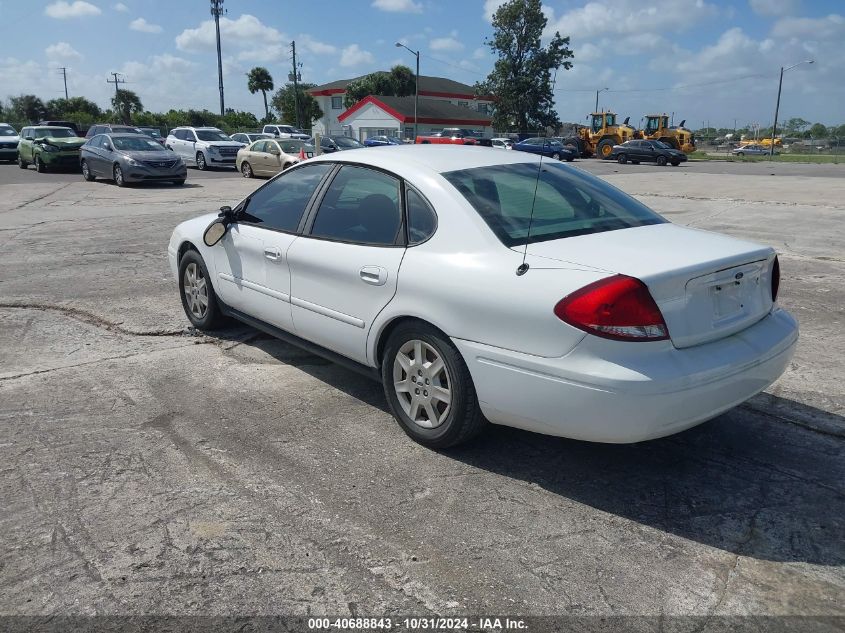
left=209, top=163, right=332, bottom=331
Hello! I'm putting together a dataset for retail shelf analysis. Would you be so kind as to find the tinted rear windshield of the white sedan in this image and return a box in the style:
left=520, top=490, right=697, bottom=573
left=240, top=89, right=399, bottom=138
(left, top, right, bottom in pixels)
left=443, top=162, right=666, bottom=246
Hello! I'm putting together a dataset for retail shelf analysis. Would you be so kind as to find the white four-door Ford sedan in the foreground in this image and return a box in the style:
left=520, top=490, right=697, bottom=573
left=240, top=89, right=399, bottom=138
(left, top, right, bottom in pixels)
left=169, top=145, right=798, bottom=448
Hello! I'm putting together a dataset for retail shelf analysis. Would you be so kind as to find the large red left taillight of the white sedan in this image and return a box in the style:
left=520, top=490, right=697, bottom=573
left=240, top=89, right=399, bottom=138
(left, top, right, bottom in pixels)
left=555, top=275, right=669, bottom=341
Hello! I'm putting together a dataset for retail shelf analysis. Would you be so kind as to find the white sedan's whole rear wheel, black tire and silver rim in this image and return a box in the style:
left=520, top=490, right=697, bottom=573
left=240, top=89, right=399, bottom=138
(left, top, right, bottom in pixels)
left=381, top=322, right=487, bottom=448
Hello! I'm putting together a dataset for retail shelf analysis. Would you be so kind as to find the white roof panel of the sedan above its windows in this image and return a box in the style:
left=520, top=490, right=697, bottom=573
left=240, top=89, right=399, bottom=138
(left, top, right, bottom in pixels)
left=308, top=144, right=539, bottom=175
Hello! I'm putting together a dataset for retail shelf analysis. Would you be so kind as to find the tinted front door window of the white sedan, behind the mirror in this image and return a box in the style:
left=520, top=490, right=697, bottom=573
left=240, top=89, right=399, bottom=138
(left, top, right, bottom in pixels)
left=239, top=163, right=332, bottom=232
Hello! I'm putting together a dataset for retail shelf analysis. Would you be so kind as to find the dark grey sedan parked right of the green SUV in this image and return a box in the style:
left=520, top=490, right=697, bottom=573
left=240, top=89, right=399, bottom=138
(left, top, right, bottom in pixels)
left=79, top=134, right=188, bottom=187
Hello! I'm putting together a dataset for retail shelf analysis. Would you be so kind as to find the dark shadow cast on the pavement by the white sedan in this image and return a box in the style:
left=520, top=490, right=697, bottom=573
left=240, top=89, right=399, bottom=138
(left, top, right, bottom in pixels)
left=213, top=328, right=845, bottom=566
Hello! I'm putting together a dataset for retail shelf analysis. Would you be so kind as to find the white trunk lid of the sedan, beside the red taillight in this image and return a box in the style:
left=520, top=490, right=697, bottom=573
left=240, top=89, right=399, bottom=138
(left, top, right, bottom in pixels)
left=514, top=223, right=775, bottom=348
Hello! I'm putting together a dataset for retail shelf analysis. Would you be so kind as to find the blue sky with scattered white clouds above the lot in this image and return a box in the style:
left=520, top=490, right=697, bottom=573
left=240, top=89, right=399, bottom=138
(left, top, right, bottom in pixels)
left=0, top=0, right=845, bottom=128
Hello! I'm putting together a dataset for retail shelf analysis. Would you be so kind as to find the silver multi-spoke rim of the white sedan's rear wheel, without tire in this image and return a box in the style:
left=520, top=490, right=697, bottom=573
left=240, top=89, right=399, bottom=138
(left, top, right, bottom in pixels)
left=393, top=339, right=452, bottom=429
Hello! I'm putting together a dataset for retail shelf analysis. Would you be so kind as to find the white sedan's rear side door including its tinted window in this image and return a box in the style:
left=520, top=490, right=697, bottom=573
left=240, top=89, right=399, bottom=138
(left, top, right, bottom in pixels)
left=287, top=165, right=405, bottom=363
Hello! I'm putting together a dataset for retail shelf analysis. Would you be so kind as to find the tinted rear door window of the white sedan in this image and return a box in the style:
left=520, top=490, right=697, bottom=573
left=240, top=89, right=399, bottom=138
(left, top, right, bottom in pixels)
left=311, top=165, right=402, bottom=246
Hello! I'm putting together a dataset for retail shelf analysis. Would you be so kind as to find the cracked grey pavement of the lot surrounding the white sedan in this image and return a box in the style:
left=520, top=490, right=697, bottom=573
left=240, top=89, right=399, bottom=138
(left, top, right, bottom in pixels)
left=0, top=161, right=845, bottom=630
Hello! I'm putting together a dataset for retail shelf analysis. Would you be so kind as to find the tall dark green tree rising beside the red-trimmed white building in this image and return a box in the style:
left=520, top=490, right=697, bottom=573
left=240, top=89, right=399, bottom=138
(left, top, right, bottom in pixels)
left=476, top=0, right=574, bottom=132
